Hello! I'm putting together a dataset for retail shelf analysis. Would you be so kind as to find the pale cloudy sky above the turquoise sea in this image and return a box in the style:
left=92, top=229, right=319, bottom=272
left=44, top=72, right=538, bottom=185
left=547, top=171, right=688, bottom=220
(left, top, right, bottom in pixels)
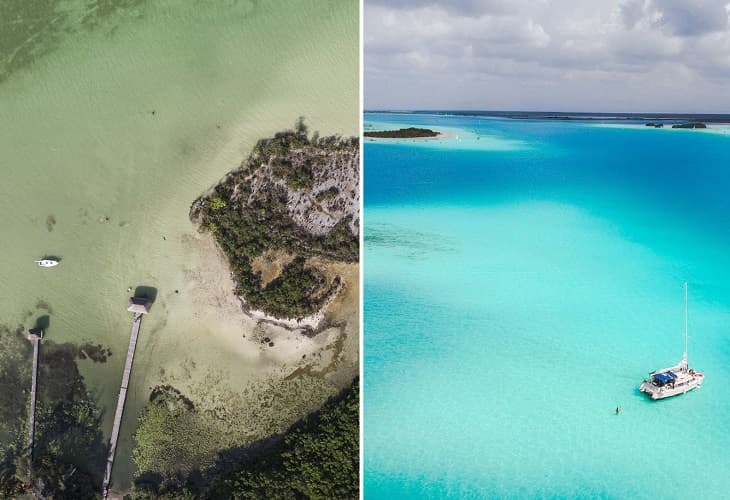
left=364, top=0, right=730, bottom=113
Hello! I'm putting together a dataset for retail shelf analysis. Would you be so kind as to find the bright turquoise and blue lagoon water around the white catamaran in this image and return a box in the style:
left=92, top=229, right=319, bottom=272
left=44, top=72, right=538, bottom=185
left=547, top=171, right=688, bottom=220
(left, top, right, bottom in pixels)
left=364, top=114, right=730, bottom=499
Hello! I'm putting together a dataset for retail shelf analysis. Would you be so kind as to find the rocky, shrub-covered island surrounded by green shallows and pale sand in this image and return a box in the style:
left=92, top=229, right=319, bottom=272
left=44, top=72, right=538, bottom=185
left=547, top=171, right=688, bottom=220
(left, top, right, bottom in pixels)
left=191, top=119, right=360, bottom=320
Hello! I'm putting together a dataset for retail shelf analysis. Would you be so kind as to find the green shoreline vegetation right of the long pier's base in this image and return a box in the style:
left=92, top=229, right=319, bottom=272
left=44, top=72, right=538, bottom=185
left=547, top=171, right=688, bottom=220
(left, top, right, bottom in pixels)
left=131, top=380, right=360, bottom=500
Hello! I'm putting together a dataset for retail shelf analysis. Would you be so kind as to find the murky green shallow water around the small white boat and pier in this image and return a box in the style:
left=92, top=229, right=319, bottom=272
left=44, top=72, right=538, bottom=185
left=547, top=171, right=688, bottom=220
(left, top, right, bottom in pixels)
left=0, top=0, right=358, bottom=488
